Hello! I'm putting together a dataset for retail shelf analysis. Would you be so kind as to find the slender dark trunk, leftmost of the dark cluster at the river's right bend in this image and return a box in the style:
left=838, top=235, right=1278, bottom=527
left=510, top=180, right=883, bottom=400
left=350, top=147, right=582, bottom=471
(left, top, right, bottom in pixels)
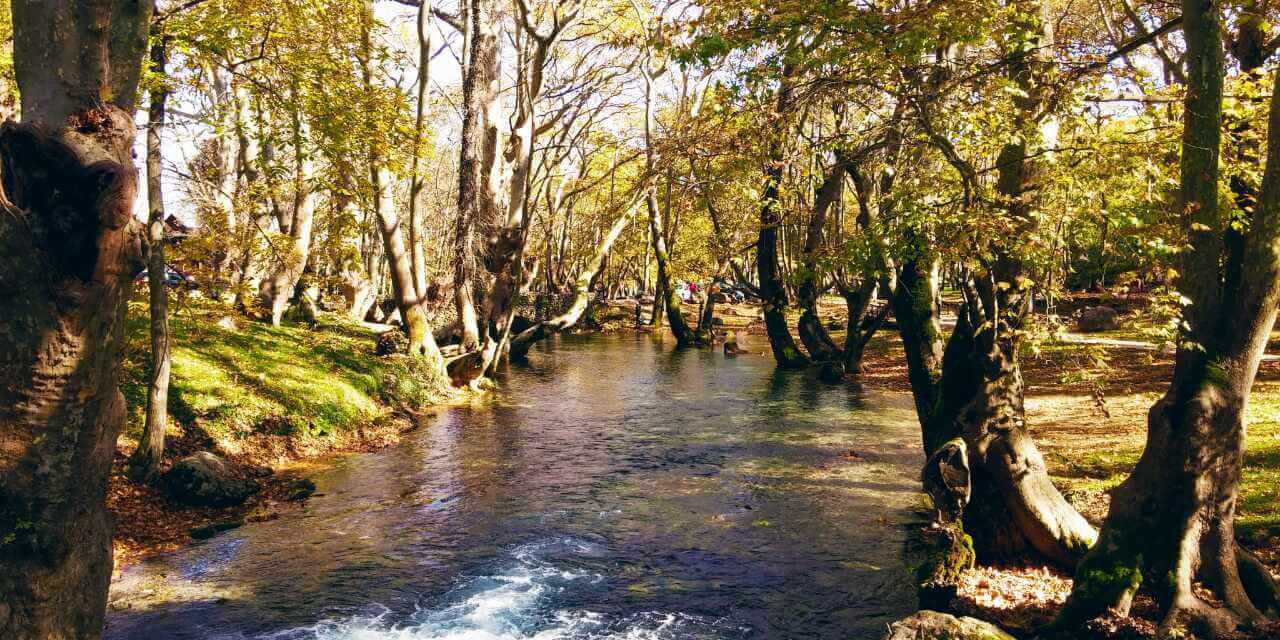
left=755, top=65, right=809, bottom=369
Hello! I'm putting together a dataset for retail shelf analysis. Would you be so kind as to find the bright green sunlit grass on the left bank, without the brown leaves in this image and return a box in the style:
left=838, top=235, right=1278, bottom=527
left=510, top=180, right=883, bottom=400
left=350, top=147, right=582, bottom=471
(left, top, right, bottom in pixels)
left=122, top=300, right=445, bottom=443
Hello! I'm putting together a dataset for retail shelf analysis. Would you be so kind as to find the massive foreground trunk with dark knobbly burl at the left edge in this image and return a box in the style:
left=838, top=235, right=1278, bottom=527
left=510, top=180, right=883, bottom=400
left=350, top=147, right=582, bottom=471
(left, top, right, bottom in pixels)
left=0, top=0, right=151, bottom=640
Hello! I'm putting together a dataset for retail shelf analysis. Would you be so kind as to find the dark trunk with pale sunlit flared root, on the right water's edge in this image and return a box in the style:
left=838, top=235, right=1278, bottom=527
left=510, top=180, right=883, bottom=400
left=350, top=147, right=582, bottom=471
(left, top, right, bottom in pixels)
left=895, top=1, right=1096, bottom=567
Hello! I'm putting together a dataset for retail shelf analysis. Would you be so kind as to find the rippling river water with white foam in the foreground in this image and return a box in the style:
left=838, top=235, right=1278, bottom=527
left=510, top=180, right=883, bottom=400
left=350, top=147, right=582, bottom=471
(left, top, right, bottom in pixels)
left=106, top=337, right=920, bottom=640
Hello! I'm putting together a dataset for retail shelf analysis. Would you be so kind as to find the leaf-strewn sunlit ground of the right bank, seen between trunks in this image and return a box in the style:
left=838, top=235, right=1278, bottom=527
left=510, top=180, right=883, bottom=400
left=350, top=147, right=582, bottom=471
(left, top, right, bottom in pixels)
left=793, top=296, right=1280, bottom=639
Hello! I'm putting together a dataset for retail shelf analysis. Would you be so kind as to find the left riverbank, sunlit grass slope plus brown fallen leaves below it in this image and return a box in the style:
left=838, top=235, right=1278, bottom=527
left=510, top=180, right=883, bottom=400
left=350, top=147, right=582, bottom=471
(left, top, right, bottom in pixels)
left=108, top=300, right=452, bottom=568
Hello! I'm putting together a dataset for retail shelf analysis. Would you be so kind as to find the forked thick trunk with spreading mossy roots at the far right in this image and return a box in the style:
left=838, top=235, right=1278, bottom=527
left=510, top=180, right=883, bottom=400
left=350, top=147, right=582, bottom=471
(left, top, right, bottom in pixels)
left=1059, top=0, right=1280, bottom=636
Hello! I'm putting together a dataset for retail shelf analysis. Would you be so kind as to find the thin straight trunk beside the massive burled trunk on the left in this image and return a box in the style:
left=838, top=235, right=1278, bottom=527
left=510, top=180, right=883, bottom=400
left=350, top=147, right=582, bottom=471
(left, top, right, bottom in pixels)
left=129, top=35, right=170, bottom=481
